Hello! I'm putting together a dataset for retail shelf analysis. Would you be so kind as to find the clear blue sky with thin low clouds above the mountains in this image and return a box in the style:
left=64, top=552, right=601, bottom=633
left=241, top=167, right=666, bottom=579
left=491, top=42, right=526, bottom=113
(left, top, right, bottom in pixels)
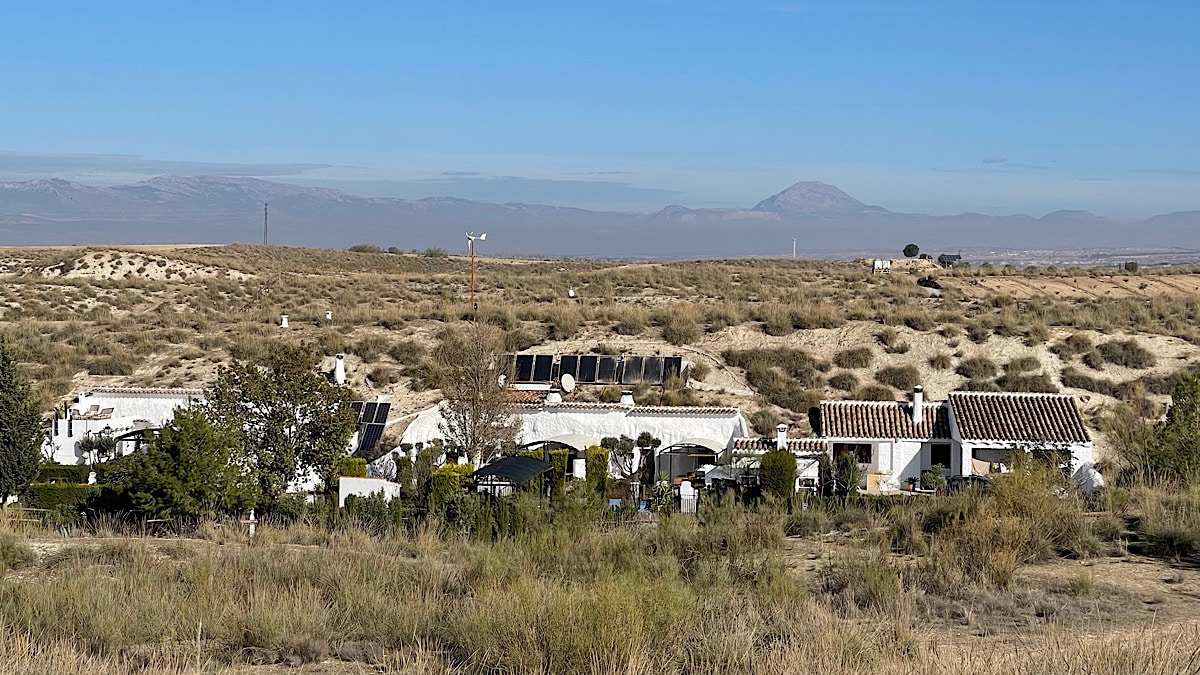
left=0, top=0, right=1200, bottom=217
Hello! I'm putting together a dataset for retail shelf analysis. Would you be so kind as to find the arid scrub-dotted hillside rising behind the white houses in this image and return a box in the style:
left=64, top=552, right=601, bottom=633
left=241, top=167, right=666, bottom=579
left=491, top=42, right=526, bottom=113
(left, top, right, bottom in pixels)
left=0, top=245, right=1200, bottom=451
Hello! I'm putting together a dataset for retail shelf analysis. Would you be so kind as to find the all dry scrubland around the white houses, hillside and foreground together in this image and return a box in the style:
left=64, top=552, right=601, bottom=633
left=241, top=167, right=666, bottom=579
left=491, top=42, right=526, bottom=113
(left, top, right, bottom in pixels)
left=0, top=246, right=1200, bottom=674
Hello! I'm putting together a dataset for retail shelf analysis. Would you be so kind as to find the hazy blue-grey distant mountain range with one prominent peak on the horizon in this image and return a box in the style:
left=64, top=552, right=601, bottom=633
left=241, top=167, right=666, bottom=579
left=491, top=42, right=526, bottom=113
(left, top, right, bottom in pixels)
left=0, top=177, right=1200, bottom=258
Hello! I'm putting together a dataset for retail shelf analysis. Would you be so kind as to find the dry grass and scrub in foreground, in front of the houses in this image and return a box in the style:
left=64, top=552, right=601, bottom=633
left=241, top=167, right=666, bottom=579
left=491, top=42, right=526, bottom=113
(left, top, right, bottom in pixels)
left=0, top=465, right=1200, bottom=674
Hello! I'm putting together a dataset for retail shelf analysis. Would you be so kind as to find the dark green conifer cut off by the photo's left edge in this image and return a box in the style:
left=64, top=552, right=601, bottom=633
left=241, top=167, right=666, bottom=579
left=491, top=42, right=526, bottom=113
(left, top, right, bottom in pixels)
left=0, top=339, right=43, bottom=504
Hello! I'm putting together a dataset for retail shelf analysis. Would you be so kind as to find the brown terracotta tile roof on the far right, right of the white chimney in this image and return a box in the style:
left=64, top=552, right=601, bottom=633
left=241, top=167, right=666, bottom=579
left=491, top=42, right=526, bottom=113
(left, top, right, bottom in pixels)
left=950, top=392, right=1092, bottom=443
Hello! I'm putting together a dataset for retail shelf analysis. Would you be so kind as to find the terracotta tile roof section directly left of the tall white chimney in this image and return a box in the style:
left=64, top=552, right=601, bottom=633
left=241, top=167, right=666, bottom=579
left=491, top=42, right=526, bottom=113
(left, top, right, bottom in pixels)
left=820, top=401, right=950, bottom=441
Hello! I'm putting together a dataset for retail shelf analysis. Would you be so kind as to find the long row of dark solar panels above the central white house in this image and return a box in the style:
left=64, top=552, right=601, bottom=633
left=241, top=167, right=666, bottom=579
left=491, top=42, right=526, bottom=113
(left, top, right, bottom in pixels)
left=512, top=354, right=683, bottom=384
